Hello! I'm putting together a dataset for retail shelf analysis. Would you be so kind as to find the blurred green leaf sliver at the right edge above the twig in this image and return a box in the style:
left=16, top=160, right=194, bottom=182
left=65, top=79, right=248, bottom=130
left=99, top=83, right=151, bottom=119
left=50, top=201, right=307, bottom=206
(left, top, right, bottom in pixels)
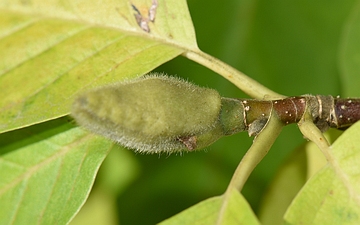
left=339, top=1, right=360, bottom=97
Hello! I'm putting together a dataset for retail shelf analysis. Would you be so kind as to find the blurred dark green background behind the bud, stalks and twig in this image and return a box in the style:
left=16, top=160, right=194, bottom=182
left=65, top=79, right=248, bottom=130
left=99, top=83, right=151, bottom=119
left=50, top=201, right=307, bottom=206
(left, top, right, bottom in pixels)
left=70, top=0, right=360, bottom=224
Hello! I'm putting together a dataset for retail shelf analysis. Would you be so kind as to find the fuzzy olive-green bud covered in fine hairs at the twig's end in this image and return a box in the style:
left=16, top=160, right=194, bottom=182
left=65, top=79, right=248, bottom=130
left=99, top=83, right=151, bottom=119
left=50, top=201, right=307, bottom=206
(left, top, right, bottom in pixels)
left=71, top=74, right=243, bottom=153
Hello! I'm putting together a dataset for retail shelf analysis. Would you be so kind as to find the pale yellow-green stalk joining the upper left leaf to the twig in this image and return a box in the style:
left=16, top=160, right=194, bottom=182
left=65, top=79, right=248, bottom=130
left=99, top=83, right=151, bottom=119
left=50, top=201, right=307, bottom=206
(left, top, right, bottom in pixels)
left=183, top=49, right=286, bottom=100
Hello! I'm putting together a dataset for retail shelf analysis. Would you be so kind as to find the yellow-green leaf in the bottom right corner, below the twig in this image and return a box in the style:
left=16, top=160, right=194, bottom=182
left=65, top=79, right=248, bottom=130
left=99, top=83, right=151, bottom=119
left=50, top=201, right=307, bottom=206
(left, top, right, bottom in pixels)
left=285, top=123, right=360, bottom=224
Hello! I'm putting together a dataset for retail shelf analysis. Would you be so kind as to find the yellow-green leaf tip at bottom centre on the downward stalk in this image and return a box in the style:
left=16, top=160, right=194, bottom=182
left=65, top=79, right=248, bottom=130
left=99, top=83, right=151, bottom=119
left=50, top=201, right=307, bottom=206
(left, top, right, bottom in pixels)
left=160, top=189, right=259, bottom=225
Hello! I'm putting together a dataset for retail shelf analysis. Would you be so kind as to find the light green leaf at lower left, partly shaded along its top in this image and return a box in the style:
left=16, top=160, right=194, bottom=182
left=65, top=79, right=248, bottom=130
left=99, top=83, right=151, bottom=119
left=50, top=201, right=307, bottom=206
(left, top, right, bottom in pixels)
left=0, top=119, right=113, bottom=224
